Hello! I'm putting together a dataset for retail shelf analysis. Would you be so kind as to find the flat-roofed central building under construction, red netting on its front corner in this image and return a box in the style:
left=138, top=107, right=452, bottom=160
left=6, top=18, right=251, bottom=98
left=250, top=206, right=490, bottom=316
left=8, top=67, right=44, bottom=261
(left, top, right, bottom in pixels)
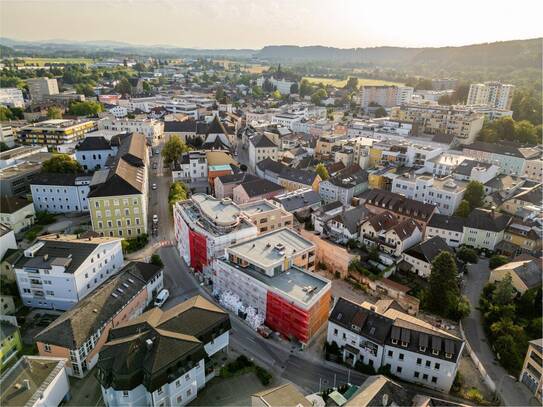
left=212, top=228, right=331, bottom=344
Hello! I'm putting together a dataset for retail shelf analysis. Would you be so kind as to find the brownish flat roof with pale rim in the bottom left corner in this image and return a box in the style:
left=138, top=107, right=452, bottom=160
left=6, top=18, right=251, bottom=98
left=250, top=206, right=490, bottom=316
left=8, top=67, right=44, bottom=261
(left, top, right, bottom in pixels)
left=0, top=356, right=66, bottom=406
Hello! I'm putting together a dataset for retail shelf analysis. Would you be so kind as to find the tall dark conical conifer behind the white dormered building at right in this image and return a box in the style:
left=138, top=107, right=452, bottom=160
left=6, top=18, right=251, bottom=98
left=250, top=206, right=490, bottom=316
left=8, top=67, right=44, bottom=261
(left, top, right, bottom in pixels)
left=426, top=252, right=460, bottom=316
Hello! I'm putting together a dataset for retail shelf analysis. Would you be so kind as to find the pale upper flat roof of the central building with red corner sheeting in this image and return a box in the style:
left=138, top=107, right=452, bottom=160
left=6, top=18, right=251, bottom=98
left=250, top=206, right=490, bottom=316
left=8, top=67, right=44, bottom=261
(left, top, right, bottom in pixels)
left=228, top=228, right=315, bottom=269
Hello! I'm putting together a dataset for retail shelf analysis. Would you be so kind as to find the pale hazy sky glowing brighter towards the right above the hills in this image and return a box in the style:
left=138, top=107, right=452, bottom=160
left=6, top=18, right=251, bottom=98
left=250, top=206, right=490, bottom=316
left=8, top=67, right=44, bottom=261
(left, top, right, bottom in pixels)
left=0, top=0, right=543, bottom=48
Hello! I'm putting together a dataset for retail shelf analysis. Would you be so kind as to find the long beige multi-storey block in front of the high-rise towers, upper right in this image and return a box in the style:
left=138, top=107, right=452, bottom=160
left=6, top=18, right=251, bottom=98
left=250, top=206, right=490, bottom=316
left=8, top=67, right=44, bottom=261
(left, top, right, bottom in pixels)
left=390, top=104, right=484, bottom=144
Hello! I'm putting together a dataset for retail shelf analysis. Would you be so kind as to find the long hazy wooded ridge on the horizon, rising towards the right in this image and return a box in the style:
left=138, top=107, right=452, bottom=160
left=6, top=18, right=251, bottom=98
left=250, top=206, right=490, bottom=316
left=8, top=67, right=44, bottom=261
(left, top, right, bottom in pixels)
left=255, top=38, right=542, bottom=68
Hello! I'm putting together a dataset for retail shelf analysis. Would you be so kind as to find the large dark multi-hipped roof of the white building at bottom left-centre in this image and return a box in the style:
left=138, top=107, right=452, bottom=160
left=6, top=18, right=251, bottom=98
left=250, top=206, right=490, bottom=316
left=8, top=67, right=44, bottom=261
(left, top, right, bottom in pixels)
left=97, top=296, right=230, bottom=392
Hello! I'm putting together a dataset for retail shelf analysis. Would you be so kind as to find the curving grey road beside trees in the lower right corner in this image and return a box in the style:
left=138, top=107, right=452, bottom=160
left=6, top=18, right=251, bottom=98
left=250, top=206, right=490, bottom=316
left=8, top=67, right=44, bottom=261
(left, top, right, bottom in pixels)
left=462, top=259, right=540, bottom=406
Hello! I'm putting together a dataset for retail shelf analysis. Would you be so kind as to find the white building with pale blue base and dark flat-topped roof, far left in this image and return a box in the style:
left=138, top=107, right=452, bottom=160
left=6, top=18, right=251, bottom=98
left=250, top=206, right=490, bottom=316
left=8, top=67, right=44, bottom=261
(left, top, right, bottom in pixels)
left=13, top=235, right=123, bottom=310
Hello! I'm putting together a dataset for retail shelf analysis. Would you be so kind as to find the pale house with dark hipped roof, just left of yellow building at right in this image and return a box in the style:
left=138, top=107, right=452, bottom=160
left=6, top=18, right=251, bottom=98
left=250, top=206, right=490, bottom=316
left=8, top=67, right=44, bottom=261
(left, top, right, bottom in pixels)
left=462, top=208, right=511, bottom=251
